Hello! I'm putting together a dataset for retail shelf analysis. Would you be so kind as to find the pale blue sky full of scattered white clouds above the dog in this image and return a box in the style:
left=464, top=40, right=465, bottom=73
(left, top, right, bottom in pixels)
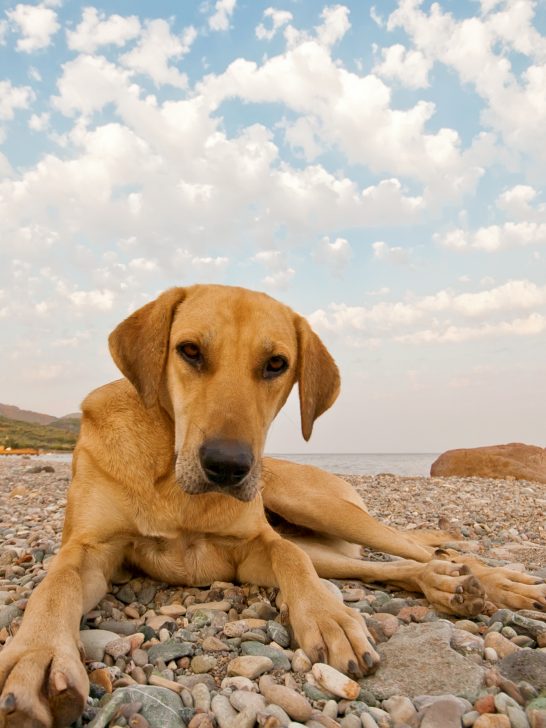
left=0, top=0, right=546, bottom=452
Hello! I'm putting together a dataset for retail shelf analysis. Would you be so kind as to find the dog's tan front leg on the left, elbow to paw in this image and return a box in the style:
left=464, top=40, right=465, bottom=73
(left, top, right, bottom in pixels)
left=0, top=538, right=122, bottom=728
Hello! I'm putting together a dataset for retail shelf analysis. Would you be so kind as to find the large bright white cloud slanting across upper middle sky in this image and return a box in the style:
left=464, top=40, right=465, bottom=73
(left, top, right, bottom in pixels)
left=198, top=30, right=480, bottom=202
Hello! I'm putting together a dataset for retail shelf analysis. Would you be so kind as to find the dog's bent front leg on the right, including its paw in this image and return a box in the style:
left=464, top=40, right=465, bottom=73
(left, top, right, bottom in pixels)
left=237, top=530, right=379, bottom=677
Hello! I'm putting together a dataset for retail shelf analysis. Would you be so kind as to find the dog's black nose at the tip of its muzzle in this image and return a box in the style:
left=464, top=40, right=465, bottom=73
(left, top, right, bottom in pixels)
left=199, top=439, right=254, bottom=486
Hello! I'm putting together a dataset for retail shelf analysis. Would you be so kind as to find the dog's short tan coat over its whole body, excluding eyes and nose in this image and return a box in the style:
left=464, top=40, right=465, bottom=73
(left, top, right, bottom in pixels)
left=0, top=286, right=545, bottom=728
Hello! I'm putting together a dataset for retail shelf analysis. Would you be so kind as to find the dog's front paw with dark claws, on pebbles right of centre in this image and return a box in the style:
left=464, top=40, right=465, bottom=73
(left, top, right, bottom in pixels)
left=289, top=589, right=379, bottom=678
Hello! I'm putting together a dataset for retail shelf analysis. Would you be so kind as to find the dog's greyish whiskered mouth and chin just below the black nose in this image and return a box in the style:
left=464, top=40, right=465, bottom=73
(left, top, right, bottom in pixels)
left=175, top=452, right=261, bottom=502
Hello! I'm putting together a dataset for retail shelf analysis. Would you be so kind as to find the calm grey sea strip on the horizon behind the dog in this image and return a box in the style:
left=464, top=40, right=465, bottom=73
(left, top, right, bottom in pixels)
left=24, top=452, right=439, bottom=477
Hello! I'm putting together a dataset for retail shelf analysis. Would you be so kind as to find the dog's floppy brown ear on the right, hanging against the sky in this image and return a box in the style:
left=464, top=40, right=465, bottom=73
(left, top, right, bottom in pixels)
left=296, top=316, right=340, bottom=440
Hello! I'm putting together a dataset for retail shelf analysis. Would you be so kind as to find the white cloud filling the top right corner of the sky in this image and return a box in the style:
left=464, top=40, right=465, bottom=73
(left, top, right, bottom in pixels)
left=387, top=0, right=546, bottom=161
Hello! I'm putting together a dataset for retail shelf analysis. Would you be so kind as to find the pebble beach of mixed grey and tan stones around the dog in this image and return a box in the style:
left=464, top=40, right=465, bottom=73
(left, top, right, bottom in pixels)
left=0, top=458, right=546, bottom=728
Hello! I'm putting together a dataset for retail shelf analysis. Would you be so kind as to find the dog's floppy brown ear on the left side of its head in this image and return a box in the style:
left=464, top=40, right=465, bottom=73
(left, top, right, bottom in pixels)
left=108, top=288, right=185, bottom=407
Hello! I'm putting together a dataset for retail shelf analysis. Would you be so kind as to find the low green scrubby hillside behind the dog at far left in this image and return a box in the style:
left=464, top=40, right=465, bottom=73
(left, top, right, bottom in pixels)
left=0, top=415, right=79, bottom=450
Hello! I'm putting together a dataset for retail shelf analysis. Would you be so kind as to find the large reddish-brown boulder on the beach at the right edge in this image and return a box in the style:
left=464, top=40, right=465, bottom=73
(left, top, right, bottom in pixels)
left=430, top=442, right=546, bottom=483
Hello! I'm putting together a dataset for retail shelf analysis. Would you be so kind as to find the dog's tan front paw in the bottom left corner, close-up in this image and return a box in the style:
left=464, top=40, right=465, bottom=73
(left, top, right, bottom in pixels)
left=0, top=637, right=89, bottom=728
